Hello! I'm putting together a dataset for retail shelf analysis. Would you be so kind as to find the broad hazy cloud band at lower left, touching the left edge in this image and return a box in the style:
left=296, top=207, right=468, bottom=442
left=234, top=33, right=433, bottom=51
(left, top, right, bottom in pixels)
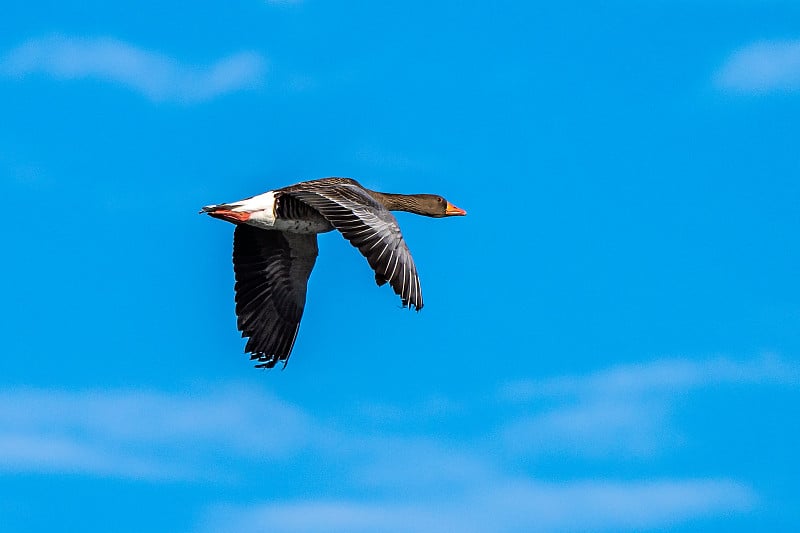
left=0, top=387, right=312, bottom=479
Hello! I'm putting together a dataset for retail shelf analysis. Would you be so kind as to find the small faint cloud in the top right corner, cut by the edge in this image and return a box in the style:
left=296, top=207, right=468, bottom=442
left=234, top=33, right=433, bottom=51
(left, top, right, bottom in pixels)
left=714, top=40, right=800, bottom=93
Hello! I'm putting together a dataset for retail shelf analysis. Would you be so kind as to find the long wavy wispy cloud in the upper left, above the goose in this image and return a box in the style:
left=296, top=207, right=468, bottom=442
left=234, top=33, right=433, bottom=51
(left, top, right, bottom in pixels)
left=0, top=35, right=266, bottom=103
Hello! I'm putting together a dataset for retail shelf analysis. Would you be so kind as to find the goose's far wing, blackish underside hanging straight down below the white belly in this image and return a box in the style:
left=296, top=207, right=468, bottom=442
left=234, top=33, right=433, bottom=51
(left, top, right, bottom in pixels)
left=233, top=224, right=317, bottom=368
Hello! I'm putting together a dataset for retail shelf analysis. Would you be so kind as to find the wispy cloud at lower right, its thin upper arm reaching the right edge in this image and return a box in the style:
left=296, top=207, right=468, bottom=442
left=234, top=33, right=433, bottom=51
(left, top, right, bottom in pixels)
left=500, top=355, right=800, bottom=458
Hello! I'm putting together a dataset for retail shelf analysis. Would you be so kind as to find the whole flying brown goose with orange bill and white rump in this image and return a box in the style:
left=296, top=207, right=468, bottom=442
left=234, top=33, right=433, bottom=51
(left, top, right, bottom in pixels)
left=200, top=177, right=467, bottom=368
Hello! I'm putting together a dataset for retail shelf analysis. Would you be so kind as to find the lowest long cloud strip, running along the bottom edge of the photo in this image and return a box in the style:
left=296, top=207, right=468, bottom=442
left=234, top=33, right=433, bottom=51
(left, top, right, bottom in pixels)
left=202, top=479, right=755, bottom=533
